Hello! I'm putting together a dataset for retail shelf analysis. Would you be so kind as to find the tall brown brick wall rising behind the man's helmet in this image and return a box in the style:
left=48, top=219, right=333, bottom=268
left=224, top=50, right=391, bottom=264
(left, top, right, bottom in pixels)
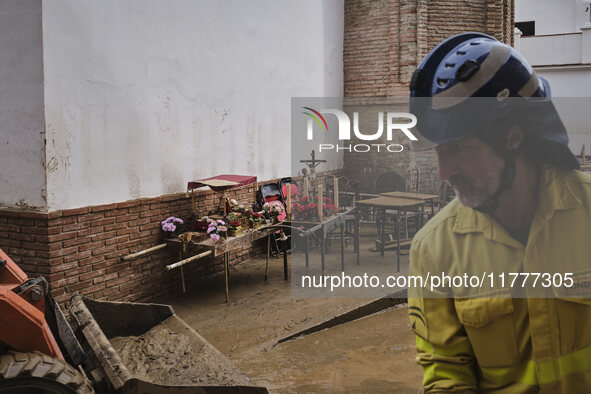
left=343, top=0, right=515, bottom=192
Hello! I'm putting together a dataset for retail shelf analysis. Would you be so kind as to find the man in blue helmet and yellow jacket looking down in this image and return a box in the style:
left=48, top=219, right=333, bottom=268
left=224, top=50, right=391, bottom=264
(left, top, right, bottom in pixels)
left=409, top=33, right=591, bottom=393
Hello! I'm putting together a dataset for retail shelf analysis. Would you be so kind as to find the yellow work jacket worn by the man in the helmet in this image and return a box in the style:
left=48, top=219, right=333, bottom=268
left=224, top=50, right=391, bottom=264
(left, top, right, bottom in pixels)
left=408, top=167, right=591, bottom=393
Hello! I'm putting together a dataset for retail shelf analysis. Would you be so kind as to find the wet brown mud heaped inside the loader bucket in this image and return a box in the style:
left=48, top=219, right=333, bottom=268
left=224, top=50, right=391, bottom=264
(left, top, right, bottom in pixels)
left=110, top=318, right=249, bottom=386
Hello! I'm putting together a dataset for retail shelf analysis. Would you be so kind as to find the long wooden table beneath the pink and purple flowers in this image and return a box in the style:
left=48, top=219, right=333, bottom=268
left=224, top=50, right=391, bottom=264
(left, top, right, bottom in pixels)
left=166, top=225, right=280, bottom=302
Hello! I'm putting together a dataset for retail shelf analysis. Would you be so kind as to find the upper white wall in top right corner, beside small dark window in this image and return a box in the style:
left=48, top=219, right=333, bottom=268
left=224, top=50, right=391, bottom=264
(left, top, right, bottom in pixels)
left=515, top=0, right=589, bottom=35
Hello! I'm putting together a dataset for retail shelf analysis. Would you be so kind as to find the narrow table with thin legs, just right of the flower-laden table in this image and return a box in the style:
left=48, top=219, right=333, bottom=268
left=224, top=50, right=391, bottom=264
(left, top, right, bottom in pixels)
left=291, top=207, right=359, bottom=276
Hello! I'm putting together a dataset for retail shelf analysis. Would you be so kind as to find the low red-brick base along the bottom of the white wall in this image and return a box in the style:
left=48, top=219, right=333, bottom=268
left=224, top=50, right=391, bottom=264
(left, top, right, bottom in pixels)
left=0, top=185, right=264, bottom=306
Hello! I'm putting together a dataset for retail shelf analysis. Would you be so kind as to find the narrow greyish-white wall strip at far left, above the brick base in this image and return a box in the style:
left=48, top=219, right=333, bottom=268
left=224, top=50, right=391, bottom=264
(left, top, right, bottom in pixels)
left=0, top=0, right=46, bottom=208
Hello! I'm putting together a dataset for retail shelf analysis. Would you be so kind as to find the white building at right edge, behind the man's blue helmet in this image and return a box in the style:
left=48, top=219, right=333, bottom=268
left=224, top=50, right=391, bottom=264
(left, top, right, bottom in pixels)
left=515, top=0, right=591, bottom=155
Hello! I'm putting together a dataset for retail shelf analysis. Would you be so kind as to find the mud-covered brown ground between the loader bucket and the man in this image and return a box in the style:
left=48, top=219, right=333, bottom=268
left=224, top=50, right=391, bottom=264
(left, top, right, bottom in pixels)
left=153, top=229, right=422, bottom=393
